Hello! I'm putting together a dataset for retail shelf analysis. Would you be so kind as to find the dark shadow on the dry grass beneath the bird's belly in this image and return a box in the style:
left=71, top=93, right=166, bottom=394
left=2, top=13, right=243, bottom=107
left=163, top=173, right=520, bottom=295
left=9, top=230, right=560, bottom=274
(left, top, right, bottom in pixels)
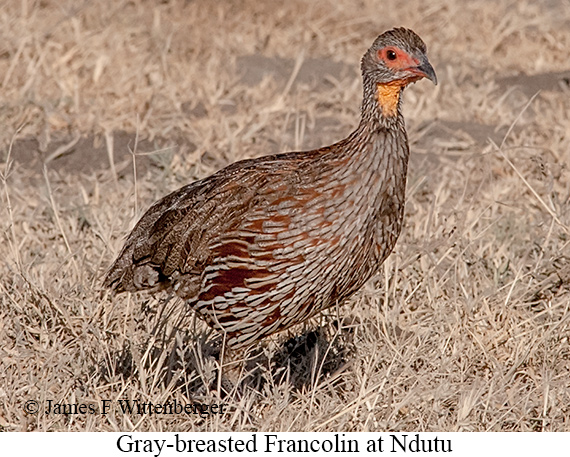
left=94, top=299, right=354, bottom=402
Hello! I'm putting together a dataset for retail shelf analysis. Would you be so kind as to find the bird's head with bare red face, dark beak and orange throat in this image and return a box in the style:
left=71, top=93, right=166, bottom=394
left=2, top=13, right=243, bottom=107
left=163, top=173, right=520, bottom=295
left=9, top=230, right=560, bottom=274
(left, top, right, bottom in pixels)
left=361, top=28, right=437, bottom=116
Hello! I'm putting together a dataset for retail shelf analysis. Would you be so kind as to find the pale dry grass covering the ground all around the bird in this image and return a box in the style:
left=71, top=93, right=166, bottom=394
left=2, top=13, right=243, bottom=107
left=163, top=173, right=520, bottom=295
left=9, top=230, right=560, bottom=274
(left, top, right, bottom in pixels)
left=0, top=0, right=570, bottom=431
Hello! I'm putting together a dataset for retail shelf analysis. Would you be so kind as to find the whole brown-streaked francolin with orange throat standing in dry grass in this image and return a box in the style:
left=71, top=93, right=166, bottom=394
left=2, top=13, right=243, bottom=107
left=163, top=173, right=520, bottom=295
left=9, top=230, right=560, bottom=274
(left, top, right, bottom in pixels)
left=103, top=27, right=437, bottom=349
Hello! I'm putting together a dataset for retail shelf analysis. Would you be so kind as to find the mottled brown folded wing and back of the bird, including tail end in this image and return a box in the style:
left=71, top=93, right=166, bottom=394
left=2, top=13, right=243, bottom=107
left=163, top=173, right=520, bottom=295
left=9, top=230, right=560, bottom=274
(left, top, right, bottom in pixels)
left=104, top=154, right=306, bottom=296
